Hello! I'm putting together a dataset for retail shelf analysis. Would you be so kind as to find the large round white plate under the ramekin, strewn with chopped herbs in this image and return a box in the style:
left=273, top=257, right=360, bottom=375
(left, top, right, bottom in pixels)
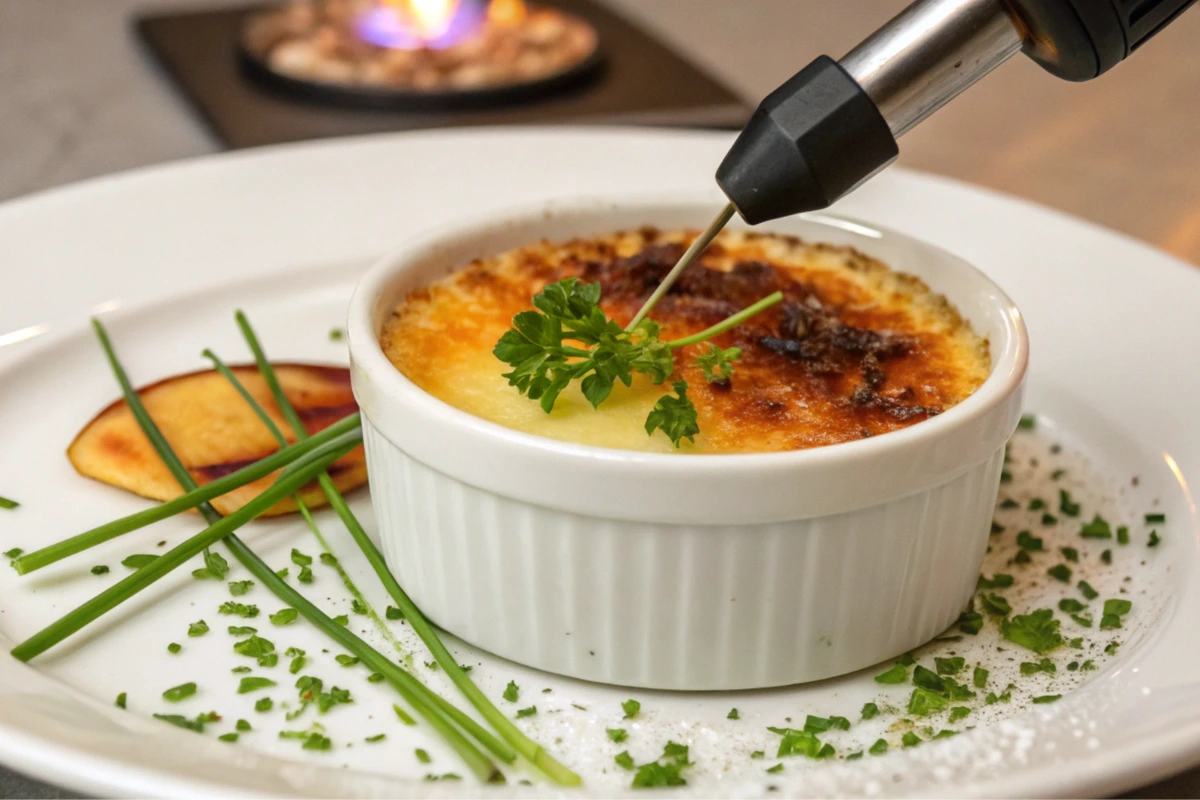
left=0, top=130, right=1200, bottom=796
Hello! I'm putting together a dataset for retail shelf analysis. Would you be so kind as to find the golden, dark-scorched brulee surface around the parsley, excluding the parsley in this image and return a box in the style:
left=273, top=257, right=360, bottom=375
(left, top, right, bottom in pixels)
left=380, top=228, right=990, bottom=453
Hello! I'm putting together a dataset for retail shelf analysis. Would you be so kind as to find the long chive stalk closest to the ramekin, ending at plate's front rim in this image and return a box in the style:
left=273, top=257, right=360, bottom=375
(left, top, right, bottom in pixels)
left=235, top=311, right=580, bottom=786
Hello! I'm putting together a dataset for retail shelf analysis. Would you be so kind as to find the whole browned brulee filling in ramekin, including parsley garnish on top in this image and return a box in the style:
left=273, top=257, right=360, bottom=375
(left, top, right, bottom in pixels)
left=380, top=228, right=990, bottom=453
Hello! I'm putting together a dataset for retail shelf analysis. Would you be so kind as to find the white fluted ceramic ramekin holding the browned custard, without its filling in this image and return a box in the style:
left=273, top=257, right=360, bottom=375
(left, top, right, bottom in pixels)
left=348, top=191, right=1028, bottom=690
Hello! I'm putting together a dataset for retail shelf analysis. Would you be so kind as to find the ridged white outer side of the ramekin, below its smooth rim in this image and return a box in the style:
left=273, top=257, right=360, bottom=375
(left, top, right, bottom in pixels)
left=364, top=419, right=1003, bottom=690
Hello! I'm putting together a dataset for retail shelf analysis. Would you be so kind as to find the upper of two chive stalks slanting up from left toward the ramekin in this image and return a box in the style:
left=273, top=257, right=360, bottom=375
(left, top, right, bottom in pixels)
left=12, top=413, right=360, bottom=575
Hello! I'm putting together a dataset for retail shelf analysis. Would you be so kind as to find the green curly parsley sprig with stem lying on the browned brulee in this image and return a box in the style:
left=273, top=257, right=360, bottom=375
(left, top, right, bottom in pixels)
left=492, top=277, right=784, bottom=447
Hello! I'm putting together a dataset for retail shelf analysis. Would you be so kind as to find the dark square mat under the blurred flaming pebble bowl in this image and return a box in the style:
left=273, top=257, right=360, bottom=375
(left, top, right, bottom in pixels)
left=136, top=0, right=749, bottom=148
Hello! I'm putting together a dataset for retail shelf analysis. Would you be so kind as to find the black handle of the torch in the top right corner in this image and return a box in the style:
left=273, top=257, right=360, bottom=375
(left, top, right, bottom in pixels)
left=1006, top=0, right=1195, bottom=80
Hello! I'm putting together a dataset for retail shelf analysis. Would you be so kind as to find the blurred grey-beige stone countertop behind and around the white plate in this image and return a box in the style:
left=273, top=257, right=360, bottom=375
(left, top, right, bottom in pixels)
left=0, top=0, right=1200, bottom=798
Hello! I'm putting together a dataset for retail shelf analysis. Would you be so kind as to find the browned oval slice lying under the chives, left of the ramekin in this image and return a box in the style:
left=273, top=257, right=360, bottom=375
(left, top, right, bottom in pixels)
left=67, top=363, right=367, bottom=516
